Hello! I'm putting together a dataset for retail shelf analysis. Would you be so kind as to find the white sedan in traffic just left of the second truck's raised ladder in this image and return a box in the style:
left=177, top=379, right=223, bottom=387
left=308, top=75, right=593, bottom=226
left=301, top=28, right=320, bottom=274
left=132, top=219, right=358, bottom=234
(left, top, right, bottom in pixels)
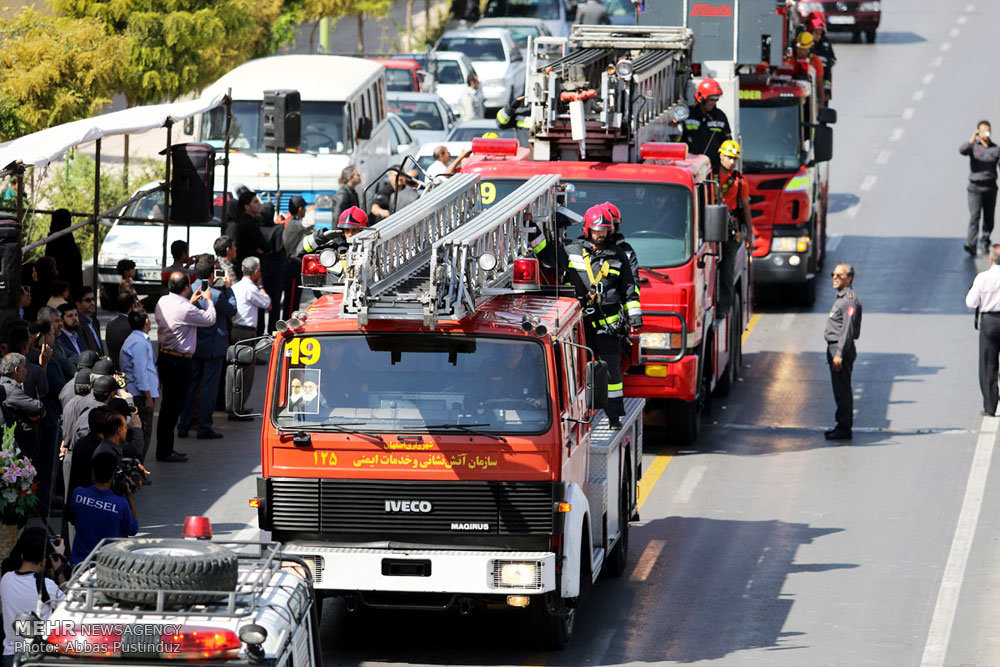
left=434, top=28, right=525, bottom=111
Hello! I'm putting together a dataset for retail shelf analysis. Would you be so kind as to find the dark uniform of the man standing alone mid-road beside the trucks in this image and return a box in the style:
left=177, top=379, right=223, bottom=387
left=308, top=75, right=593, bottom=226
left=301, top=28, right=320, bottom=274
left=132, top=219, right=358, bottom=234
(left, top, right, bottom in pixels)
left=823, top=287, right=861, bottom=435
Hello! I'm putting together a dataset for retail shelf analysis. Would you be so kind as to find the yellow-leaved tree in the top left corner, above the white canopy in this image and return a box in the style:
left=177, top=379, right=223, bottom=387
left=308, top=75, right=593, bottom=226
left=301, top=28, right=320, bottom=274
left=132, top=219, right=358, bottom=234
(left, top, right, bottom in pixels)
left=0, top=8, right=122, bottom=140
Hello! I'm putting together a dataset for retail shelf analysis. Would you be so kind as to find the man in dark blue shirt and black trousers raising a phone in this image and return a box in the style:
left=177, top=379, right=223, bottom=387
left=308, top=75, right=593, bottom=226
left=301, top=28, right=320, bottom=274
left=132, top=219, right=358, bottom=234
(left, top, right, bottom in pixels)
left=177, top=255, right=236, bottom=440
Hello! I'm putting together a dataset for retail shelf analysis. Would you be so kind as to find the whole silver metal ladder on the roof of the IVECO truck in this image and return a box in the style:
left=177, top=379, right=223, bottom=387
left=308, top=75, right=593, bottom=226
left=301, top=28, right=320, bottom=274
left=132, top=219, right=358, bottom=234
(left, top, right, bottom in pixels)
left=341, top=174, right=559, bottom=328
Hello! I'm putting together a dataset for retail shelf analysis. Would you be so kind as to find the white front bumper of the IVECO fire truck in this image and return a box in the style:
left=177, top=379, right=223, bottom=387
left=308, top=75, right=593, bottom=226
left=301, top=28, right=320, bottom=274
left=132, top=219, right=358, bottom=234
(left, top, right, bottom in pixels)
left=283, top=542, right=556, bottom=595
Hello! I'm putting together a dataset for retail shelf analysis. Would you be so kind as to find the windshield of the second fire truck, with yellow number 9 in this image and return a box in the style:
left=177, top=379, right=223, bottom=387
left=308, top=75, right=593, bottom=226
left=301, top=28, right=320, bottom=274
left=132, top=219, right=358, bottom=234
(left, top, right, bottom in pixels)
left=479, top=181, right=694, bottom=268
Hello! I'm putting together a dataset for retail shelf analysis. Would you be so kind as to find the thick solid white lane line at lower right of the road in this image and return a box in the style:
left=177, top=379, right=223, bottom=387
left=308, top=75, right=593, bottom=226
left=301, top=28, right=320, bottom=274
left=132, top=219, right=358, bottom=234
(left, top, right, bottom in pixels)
left=920, top=417, right=1000, bottom=667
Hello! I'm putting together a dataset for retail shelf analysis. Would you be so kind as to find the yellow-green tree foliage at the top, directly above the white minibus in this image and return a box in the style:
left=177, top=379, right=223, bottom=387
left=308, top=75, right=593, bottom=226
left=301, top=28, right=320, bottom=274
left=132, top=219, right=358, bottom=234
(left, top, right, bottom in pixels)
left=52, top=0, right=281, bottom=104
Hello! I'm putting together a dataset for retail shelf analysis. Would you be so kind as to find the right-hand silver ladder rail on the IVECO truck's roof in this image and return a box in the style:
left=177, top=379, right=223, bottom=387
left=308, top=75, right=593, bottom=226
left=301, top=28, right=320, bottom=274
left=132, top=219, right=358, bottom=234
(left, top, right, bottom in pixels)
left=428, top=174, right=559, bottom=325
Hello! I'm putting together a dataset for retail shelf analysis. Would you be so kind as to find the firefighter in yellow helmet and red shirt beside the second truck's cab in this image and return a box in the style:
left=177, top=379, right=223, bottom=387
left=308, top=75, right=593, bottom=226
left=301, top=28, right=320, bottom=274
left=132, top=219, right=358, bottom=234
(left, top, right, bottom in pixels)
left=717, top=139, right=753, bottom=317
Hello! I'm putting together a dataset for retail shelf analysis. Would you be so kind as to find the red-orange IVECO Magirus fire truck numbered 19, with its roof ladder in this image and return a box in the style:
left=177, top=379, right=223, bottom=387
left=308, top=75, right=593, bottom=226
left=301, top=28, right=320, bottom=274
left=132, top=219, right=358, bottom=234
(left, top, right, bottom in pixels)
left=227, top=174, right=644, bottom=648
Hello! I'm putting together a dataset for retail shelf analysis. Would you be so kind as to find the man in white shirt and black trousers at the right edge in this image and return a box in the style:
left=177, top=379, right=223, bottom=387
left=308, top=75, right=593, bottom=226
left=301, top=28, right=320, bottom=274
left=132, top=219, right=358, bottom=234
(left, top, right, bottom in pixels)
left=965, top=245, right=1000, bottom=417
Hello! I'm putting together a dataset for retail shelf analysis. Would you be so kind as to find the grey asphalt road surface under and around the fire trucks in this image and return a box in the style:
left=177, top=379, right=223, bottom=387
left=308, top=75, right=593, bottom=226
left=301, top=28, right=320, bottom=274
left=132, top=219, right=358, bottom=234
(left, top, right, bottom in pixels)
left=138, top=0, right=1000, bottom=667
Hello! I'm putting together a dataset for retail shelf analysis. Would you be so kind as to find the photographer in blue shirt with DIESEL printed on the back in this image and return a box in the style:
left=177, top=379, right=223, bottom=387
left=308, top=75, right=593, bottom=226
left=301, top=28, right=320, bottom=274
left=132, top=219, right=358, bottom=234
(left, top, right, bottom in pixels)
left=71, top=446, right=139, bottom=565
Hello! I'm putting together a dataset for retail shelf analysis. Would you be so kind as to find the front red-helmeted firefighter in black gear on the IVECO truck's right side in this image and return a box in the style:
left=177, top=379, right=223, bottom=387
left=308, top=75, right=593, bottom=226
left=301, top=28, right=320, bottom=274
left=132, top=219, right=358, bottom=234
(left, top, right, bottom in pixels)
left=530, top=204, right=642, bottom=429
